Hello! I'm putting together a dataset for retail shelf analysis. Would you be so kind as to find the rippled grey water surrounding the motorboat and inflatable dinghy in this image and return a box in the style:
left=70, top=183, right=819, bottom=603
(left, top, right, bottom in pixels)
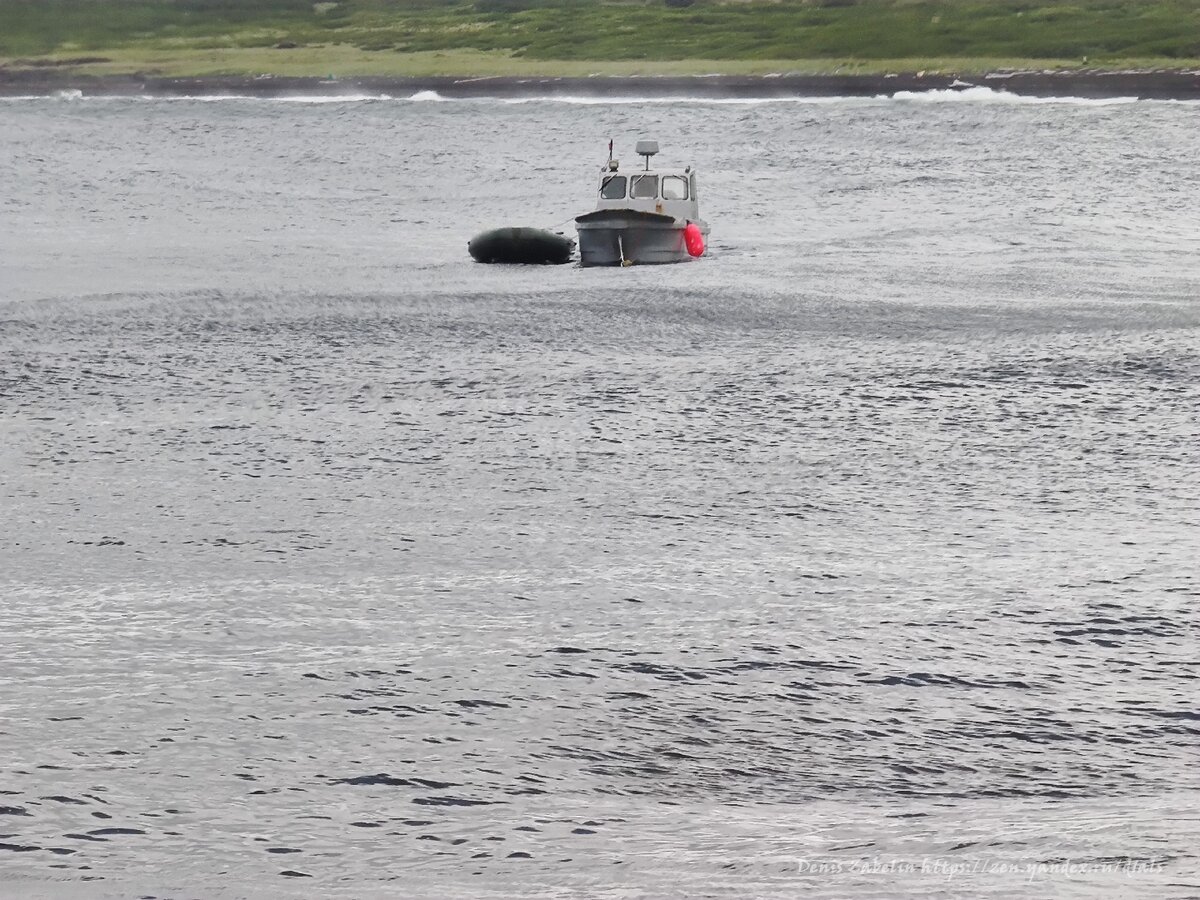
left=0, top=92, right=1200, bottom=898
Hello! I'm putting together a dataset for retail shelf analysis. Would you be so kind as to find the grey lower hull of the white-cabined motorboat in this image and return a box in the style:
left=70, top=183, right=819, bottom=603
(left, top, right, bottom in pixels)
left=575, top=210, right=708, bottom=265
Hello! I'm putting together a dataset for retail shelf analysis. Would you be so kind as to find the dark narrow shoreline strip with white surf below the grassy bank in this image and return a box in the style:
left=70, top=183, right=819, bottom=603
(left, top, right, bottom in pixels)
left=0, top=66, right=1200, bottom=100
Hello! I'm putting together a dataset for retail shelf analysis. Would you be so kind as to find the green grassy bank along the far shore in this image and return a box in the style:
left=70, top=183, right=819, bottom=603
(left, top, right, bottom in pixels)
left=0, top=0, right=1200, bottom=76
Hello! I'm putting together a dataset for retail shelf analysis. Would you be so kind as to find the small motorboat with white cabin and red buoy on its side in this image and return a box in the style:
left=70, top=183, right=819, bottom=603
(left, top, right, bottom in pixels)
left=575, top=140, right=708, bottom=266
